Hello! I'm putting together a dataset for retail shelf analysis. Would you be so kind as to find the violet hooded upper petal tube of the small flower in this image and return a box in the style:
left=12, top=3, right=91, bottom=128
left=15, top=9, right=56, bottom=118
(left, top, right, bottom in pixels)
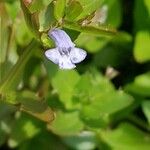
left=48, top=29, right=75, bottom=48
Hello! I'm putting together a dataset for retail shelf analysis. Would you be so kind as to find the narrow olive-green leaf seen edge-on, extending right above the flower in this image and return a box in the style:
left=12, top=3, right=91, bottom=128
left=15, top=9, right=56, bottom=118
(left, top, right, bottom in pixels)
left=64, top=21, right=116, bottom=37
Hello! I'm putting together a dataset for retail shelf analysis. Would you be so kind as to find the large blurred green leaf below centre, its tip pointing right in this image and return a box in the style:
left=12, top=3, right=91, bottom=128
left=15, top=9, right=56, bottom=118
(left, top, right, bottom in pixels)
left=81, top=91, right=133, bottom=128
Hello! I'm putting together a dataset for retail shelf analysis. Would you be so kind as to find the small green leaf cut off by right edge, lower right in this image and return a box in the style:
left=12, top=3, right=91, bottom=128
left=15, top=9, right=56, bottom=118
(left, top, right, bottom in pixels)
left=142, top=100, right=150, bottom=125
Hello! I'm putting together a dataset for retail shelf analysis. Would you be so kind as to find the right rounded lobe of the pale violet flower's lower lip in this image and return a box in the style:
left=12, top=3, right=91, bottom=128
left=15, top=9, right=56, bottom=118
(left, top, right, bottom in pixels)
left=70, top=48, right=87, bottom=63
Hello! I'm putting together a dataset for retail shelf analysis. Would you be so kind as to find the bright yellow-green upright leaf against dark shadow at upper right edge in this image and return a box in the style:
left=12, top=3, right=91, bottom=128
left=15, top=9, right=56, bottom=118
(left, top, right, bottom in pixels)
left=134, top=31, right=150, bottom=63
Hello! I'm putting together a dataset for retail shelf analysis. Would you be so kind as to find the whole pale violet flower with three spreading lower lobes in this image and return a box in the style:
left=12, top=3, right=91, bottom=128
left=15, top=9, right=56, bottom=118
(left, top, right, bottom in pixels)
left=45, top=29, right=87, bottom=69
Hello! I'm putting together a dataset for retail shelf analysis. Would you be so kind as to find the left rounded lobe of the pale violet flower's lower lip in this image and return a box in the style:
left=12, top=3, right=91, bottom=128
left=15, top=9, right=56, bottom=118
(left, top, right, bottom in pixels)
left=45, top=48, right=62, bottom=64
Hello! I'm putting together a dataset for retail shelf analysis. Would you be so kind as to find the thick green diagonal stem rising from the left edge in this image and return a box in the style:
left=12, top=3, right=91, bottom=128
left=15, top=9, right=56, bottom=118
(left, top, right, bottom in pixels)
left=0, top=40, right=38, bottom=94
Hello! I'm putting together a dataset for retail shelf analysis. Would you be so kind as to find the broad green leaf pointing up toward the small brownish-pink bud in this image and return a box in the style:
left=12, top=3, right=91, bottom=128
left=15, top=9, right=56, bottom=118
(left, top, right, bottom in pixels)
left=74, top=70, right=114, bottom=105
